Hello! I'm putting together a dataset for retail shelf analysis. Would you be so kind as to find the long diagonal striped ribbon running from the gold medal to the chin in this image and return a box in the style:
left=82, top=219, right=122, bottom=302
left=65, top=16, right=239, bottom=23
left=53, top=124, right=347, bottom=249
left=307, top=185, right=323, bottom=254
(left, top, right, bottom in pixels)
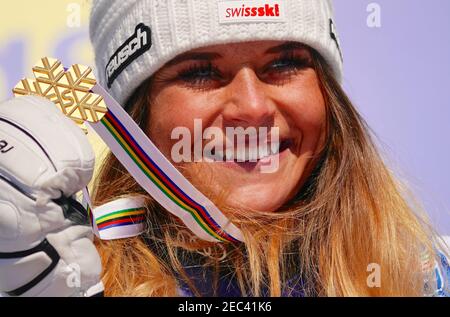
left=87, top=85, right=243, bottom=242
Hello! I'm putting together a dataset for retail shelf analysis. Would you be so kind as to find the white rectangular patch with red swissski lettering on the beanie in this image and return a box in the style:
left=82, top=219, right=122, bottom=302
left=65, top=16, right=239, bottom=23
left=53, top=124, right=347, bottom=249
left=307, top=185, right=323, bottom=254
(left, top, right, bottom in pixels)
left=218, top=0, right=286, bottom=24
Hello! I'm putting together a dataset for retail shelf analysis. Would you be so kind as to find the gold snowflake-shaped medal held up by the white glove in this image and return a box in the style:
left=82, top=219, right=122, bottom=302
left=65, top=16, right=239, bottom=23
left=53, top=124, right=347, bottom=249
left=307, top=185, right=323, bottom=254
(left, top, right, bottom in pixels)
left=13, top=57, right=108, bottom=133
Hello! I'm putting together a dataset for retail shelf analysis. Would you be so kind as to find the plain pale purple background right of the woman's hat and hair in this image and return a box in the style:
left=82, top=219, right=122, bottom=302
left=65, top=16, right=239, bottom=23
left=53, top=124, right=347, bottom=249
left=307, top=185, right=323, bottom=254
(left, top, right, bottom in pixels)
left=335, top=0, right=450, bottom=235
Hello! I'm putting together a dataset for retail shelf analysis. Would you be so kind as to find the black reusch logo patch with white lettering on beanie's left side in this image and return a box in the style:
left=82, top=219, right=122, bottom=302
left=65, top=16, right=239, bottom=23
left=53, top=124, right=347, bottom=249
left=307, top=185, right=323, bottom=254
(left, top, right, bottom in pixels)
left=105, top=23, right=152, bottom=88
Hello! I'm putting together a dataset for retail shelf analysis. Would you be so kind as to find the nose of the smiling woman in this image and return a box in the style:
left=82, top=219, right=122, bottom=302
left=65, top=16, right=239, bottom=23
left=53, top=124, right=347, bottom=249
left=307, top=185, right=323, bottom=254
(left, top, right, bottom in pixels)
left=222, top=67, right=276, bottom=127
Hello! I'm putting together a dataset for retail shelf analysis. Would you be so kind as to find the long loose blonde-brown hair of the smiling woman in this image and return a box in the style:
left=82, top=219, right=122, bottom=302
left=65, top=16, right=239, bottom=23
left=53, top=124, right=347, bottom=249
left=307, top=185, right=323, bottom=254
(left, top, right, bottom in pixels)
left=90, top=51, right=442, bottom=296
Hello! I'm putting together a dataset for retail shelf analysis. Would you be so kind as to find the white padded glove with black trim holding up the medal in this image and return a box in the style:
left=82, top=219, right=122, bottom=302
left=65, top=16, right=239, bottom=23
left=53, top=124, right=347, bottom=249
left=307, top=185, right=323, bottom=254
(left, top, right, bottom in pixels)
left=0, top=96, right=103, bottom=297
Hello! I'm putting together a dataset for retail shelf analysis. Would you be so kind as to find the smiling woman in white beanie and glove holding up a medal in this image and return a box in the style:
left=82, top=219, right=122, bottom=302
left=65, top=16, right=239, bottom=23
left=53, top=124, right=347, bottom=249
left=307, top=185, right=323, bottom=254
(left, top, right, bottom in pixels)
left=0, top=0, right=450, bottom=296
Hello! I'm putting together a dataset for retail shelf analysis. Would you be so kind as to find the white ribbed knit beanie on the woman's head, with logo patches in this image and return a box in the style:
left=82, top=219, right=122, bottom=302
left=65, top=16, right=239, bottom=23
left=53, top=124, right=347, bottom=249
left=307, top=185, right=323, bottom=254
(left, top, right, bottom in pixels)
left=90, top=0, right=342, bottom=106
